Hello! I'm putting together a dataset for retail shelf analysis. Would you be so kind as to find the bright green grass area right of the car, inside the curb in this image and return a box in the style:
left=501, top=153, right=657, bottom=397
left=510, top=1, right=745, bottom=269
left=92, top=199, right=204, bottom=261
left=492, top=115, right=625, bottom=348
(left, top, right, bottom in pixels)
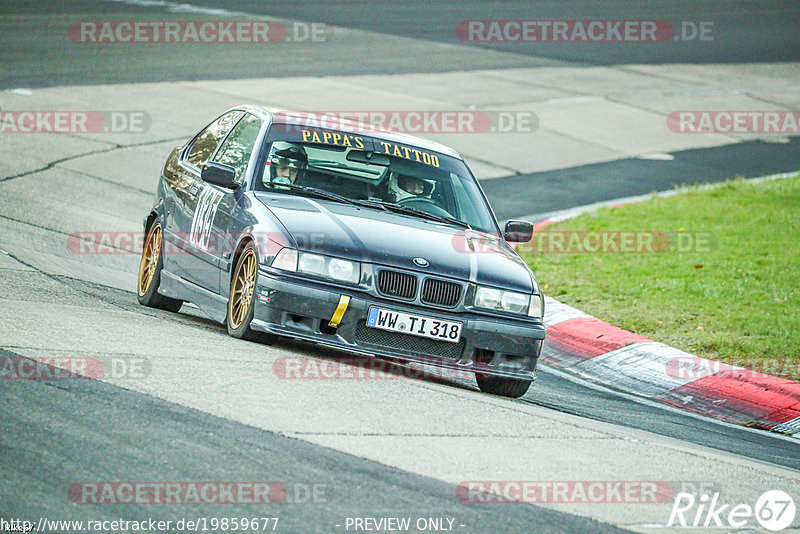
left=520, top=176, right=800, bottom=380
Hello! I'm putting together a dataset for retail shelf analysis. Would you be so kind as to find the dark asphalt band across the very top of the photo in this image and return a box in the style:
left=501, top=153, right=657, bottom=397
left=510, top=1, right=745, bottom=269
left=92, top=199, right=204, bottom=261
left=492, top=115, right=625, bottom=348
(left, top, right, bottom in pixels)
left=0, top=0, right=800, bottom=88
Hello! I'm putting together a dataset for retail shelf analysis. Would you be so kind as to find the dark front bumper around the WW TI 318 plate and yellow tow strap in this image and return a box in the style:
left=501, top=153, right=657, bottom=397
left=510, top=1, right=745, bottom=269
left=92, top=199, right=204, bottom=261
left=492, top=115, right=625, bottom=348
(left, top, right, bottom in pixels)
left=251, top=269, right=546, bottom=380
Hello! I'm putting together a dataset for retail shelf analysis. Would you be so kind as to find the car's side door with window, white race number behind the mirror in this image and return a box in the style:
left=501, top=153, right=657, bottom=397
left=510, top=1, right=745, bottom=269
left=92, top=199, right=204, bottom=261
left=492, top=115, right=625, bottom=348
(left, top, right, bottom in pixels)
left=195, top=113, right=263, bottom=295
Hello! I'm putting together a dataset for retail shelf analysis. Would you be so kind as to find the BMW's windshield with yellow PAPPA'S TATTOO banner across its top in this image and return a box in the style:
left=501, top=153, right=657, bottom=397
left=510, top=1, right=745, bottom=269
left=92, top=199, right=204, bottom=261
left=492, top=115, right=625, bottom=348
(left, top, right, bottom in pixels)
left=255, top=126, right=498, bottom=234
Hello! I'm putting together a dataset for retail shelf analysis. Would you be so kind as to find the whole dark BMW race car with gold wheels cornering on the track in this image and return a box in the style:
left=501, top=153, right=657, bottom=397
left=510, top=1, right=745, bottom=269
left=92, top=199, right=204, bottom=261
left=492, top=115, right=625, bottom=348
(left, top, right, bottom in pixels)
left=137, top=106, right=545, bottom=397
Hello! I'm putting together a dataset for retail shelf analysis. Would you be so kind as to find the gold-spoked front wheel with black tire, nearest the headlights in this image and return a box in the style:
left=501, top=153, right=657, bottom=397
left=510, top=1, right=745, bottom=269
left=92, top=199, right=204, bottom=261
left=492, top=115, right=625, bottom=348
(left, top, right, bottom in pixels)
left=225, top=243, right=259, bottom=341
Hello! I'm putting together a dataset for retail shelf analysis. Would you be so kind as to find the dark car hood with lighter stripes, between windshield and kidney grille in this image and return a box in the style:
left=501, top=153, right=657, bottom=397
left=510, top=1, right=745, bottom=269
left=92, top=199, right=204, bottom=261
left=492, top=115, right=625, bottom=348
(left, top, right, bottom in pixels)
left=256, top=193, right=533, bottom=292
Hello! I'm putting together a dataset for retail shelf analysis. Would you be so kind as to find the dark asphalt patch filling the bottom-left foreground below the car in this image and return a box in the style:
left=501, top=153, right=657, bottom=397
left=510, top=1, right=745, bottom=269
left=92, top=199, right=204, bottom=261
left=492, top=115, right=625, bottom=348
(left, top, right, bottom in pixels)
left=0, top=340, right=618, bottom=532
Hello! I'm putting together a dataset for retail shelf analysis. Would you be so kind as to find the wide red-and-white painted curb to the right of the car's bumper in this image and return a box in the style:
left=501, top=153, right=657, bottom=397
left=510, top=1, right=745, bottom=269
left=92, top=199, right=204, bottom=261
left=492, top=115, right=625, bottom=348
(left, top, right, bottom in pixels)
left=542, top=297, right=800, bottom=436
